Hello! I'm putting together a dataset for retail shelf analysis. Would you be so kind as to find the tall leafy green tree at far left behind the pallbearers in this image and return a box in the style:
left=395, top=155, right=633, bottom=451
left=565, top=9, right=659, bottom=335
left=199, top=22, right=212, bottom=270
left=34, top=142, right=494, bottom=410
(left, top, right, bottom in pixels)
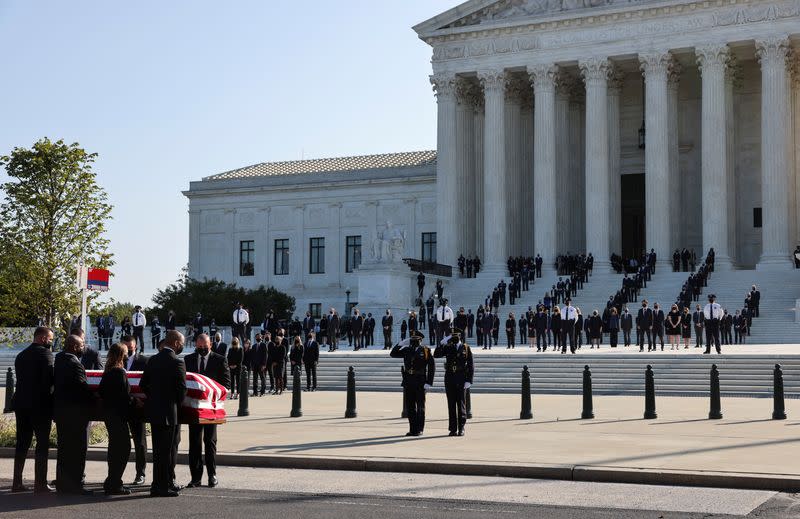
left=0, top=138, right=113, bottom=327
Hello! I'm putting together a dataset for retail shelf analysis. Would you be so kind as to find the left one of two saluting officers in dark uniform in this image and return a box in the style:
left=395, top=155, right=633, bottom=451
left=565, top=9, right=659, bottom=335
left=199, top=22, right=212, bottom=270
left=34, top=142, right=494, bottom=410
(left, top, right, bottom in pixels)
left=389, top=331, right=436, bottom=436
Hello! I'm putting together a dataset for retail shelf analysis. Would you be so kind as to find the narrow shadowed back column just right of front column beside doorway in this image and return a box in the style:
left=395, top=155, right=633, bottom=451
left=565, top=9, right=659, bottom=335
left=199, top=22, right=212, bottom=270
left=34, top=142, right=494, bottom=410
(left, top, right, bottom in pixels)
left=665, top=63, right=685, bottom=259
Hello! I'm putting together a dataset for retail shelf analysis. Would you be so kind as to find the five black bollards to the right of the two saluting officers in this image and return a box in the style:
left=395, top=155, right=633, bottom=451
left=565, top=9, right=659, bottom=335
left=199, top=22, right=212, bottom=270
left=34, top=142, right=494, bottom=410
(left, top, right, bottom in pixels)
left=519, top=364, right=786, bottom=420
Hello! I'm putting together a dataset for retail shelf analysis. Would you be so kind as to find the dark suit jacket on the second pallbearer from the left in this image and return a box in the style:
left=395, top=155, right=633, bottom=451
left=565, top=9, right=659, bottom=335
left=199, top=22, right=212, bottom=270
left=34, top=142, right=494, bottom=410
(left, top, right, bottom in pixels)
left=53, top=351, right=96, bottom=420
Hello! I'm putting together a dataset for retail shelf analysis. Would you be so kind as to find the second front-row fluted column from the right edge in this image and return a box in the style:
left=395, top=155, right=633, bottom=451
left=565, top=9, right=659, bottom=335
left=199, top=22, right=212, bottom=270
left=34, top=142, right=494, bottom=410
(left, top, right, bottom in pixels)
left=695, top=44, right=731, bottom=268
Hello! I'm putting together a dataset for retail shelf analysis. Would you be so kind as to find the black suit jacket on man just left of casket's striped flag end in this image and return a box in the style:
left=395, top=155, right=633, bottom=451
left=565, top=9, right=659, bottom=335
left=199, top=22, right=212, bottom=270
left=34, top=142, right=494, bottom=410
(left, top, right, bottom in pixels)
left=139, top=348, right=186, bottom=425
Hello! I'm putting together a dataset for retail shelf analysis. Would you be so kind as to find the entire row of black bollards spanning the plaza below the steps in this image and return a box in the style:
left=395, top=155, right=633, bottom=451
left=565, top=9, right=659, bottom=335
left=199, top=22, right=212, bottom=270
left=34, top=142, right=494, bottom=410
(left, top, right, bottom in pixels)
left=230, top=364, right=786, bottom=420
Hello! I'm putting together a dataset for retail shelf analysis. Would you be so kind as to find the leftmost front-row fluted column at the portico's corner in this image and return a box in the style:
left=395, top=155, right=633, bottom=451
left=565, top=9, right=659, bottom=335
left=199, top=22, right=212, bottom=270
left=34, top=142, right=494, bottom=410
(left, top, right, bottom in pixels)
left=430, top=74, right=459, bottom=266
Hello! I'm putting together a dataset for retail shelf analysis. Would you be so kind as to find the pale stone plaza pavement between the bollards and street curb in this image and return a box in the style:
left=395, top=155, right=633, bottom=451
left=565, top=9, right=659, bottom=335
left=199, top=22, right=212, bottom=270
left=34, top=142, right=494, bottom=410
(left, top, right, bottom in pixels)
left=81, top=392, right=800, bottom=490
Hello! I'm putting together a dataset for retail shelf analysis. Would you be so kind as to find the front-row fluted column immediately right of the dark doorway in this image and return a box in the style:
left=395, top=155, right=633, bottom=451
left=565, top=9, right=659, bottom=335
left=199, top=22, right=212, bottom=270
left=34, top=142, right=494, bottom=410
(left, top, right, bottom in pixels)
left=639, top=51, right=673, bottom=265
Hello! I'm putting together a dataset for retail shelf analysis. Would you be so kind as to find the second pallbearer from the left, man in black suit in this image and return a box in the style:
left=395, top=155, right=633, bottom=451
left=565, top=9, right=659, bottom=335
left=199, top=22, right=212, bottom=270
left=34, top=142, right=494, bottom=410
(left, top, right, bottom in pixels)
left=53, top=335, right=97, bottom=495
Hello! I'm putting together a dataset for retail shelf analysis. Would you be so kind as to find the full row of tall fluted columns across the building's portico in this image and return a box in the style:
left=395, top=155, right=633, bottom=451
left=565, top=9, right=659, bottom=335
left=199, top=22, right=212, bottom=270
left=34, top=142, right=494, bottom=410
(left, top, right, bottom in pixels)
left=431, top=36, right=795, bottom=273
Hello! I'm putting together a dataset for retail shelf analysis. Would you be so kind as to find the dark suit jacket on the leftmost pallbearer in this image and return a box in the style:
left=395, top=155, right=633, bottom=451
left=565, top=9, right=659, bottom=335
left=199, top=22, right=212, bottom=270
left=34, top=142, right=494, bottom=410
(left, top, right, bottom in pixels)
left=14, top=344, right=53, bottom=416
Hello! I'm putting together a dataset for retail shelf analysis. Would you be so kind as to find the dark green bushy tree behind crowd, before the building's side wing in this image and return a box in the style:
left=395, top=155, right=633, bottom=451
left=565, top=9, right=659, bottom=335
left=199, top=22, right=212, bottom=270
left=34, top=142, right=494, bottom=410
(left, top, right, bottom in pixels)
left=149, top=271, right=295, bottom=326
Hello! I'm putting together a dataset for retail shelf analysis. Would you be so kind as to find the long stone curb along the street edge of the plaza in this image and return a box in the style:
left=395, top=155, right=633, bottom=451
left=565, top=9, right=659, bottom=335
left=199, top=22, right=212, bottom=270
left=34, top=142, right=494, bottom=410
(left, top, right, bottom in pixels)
left=0, top=447, right=800, bottom=492
